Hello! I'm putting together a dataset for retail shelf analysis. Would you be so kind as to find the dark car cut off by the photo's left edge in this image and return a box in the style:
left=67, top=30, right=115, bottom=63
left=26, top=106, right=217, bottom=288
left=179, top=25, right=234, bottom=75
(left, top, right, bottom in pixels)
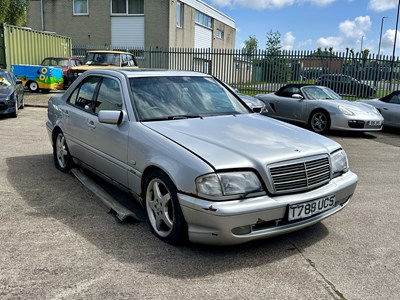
left=0, top=69, right=24, bottom=118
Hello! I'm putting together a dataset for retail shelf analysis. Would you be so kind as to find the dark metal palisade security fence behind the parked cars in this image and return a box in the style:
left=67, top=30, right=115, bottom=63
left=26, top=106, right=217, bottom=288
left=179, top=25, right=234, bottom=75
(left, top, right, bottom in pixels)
left=72, top=45, right=400, bottom=99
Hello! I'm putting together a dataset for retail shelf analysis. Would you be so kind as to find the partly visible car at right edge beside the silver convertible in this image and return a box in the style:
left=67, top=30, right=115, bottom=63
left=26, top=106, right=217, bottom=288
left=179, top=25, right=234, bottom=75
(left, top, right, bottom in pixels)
left=362, top=91, right=400, bottom=128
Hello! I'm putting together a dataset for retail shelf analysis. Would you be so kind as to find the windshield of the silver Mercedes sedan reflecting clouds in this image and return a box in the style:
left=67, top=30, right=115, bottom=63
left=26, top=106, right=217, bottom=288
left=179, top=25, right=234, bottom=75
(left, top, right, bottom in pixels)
left=130, top=76, right=250, bottom=121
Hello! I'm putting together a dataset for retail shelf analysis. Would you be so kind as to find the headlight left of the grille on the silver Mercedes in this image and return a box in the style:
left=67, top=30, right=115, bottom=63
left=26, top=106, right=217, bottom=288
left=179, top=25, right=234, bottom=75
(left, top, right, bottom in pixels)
left=196, top=172, right=262, bottom=197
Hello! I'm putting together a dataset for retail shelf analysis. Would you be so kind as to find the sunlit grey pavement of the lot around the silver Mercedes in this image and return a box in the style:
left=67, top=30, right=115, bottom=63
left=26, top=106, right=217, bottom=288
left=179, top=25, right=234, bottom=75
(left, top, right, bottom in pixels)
left=0, top=92, right=400, bottom=300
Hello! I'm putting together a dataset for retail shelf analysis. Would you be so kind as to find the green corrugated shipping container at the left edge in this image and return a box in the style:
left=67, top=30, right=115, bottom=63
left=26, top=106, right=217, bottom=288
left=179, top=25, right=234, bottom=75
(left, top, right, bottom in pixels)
left=0, top=24, right=72, bottom=70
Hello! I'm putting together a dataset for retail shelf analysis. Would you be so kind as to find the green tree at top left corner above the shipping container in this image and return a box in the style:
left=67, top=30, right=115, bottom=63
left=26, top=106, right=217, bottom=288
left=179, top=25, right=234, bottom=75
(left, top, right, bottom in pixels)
left=0, top=0, right=29, bottom=26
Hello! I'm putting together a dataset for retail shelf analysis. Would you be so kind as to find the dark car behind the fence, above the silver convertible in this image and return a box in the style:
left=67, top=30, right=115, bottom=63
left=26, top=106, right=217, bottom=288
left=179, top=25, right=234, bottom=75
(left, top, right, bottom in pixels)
left=315, top=74, right=376, bottom=98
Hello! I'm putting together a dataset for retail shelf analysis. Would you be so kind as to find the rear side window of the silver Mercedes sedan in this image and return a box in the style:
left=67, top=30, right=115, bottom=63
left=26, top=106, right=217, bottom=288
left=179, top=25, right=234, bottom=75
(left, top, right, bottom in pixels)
left=68, top=76, right=101, bottom=112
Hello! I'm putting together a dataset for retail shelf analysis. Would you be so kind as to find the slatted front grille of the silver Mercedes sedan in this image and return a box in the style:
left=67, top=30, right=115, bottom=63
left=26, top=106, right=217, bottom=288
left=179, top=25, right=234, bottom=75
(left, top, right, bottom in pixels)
left=269, top=157, right=331, bottom=194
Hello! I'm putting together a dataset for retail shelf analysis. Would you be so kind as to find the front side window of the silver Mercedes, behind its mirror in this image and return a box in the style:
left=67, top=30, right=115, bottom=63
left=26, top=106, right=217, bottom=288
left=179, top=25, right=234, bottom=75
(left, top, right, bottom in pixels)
left=95, top=78, right=122, bottom=114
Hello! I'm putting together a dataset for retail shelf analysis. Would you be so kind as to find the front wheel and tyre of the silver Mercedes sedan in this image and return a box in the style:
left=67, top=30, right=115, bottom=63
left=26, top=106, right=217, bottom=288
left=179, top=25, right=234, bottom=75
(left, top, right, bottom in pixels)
left=144, top=171, right=187, bottom=245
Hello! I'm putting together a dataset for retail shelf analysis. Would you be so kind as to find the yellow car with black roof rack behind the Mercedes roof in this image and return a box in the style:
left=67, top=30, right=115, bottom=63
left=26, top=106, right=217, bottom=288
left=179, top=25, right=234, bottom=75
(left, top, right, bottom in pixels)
left=68, top=50, right=138, bottom=82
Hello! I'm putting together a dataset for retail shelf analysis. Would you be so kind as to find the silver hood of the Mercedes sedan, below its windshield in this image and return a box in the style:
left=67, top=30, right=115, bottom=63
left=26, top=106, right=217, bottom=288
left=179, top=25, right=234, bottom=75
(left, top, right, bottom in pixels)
left=144, top=114, right=340, bottom=169
